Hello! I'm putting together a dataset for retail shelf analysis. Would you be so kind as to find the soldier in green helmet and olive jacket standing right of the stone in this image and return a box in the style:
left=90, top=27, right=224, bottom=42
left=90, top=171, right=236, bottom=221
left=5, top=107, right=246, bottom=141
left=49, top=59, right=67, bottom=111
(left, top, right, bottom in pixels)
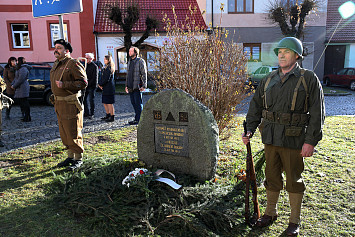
left=242, top=37, right=325, bottom=236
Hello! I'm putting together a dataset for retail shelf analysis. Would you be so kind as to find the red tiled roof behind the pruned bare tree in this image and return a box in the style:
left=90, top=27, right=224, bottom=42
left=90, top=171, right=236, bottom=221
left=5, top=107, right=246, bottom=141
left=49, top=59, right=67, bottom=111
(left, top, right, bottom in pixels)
left=94, top=0, right=206, bottom=33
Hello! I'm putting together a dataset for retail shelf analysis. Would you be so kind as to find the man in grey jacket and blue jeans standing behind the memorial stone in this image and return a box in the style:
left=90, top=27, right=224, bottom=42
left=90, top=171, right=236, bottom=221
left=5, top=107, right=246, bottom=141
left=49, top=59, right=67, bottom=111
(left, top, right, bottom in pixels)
left=125, top=47, right=147, bottom=125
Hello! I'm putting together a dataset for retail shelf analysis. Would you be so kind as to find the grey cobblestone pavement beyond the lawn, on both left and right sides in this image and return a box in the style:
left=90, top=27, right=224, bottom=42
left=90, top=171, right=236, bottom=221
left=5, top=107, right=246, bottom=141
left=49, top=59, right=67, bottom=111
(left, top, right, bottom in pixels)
left=0, top=90, right=355, bottom=153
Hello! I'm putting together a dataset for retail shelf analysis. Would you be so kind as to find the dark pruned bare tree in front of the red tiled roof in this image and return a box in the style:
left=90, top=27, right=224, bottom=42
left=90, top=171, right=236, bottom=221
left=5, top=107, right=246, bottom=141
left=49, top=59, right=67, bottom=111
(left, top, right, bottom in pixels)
left=108, top=1, right=159, bottom=59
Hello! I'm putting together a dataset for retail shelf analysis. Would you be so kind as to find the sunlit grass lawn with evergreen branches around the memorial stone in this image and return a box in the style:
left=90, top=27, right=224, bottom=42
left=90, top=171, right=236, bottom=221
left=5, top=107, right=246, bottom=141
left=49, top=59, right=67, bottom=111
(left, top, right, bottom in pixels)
left=0, top=116, right=355, bottom=236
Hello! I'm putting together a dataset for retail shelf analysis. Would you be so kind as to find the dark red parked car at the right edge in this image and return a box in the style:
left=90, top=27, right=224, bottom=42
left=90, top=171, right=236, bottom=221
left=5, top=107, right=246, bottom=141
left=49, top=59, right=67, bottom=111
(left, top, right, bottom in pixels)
left=323, top=68, right=355, bottom=90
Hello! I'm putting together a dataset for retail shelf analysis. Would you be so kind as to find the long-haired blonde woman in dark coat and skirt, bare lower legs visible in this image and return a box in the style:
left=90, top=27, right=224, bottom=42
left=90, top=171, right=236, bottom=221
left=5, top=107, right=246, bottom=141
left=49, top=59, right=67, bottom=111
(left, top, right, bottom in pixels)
left=99, top=55, right=115, bottom=122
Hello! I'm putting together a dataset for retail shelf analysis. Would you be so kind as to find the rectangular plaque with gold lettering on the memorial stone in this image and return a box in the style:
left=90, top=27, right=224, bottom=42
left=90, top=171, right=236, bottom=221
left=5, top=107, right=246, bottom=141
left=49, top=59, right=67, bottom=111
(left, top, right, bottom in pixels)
left=155, top=124, right=189, bottom=157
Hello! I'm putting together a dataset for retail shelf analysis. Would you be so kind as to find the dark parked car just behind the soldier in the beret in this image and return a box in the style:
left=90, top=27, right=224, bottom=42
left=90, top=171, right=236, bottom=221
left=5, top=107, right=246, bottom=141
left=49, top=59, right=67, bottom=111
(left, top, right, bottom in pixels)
left=28, top=65, right=52, bottom=105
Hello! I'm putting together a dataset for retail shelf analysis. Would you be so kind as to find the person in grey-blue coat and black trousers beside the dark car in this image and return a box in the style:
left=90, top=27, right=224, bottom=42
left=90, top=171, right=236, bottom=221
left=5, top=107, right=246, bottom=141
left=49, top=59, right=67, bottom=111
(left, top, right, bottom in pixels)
left=11, top=57, right=31, bottom=122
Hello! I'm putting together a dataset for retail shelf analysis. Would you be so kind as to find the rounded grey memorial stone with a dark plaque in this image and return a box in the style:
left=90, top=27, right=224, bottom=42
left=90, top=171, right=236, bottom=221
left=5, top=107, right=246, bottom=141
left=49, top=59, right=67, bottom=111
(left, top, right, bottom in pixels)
left=137, top=89, right=219, bottom=181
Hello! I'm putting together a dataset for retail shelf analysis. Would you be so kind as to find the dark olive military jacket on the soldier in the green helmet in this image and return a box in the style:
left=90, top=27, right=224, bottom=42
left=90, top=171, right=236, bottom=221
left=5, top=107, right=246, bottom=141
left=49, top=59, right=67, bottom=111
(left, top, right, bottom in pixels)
left=246, top=64, right=325, bottom=149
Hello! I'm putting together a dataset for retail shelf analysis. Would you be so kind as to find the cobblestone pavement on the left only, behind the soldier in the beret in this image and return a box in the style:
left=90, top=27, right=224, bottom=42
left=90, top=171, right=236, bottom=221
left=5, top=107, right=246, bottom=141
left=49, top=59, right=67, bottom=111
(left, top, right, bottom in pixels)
left=0, top=93, right=152, bottom=153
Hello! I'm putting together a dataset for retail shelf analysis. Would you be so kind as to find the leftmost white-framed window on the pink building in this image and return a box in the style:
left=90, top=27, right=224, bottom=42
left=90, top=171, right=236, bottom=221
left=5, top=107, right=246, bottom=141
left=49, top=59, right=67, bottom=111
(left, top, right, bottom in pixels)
left=11, top=24, right=30, bottom=49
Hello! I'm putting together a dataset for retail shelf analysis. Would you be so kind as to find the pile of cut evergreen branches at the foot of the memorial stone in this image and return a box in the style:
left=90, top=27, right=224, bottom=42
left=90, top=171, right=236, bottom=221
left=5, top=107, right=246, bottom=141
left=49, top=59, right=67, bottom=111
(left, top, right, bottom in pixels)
left=26, top=158, right=265, bottom=236
